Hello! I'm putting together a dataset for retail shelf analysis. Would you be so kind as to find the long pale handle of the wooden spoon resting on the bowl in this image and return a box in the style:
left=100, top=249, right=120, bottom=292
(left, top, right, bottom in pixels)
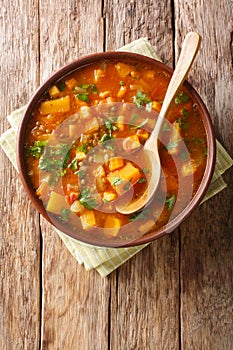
left=151, top=32, right=201, bottom=144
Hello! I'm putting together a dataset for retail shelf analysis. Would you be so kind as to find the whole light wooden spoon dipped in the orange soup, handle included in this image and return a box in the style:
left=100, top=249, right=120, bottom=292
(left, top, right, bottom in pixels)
left=116, top=32, right=201, bottom=214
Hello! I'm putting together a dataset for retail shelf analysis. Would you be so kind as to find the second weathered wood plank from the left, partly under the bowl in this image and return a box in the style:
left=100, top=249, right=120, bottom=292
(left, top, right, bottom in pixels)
left=40, top=0, right=110, bottom=350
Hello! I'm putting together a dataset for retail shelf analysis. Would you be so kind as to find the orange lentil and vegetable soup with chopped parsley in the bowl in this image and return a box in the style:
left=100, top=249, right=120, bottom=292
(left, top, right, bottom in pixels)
left=25, top=60, right=207, bottom=241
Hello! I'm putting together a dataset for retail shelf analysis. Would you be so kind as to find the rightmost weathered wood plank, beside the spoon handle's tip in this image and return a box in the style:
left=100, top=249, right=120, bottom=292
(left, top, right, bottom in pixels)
left=175, top=0, right=233, bottom=350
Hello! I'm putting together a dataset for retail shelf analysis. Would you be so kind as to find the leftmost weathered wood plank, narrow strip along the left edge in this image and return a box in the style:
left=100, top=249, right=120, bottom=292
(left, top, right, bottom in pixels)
left=0, top=0, right=40, bottom=350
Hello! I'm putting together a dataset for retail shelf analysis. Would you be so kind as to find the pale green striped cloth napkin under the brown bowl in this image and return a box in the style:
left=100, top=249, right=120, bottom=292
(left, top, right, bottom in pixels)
left=0, top=38, right=233, bottom=277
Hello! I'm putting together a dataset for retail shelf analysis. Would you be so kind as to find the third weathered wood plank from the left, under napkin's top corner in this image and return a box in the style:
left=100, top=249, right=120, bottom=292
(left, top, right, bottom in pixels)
left=105, top=0, right=179, bottom=350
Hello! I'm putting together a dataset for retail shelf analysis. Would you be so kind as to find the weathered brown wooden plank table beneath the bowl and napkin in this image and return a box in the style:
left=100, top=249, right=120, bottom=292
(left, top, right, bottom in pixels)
left=0, top=0, right=233, bottom=350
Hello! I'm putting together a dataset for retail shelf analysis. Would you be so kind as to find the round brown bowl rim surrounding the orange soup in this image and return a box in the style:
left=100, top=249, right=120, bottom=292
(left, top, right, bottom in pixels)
left=17, top=52, right=216, bottom=247
